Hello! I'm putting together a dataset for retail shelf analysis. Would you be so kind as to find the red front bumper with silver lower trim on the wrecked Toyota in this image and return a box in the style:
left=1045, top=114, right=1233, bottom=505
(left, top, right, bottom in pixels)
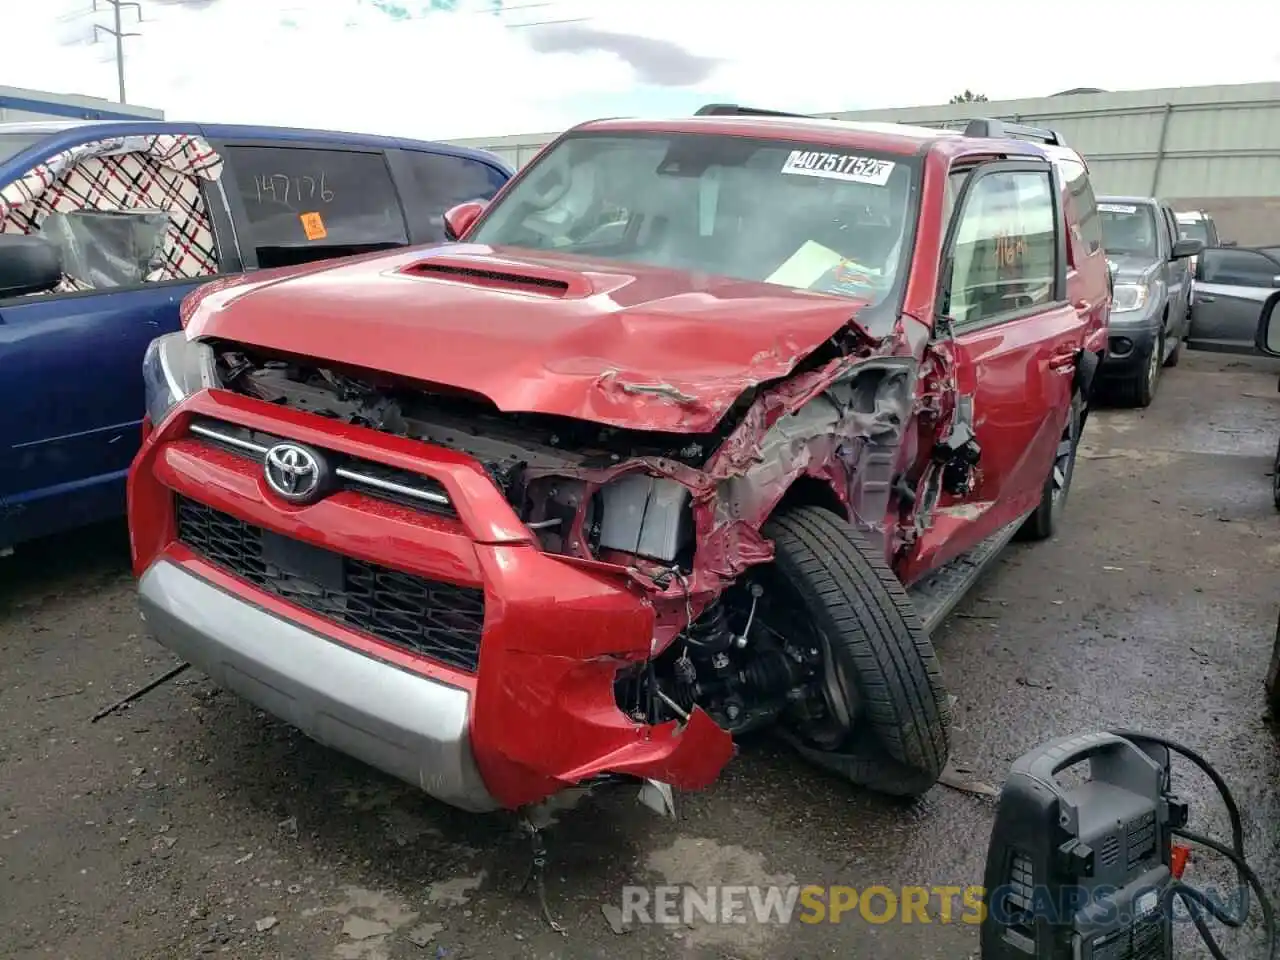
left=129, top=390, right=733, bottom=809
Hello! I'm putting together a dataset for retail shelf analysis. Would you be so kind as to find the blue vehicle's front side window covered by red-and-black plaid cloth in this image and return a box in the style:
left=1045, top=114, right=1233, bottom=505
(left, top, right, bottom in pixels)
left=0, top=134, right=223, bottom=297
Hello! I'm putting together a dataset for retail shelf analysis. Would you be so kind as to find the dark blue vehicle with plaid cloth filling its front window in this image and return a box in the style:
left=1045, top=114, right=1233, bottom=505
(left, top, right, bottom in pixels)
left=0, top=122, right=511, bottom=553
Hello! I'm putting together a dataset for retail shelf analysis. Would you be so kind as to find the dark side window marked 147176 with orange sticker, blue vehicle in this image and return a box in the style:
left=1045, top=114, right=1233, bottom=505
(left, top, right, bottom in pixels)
left=227, top=146, right=408, bottom=268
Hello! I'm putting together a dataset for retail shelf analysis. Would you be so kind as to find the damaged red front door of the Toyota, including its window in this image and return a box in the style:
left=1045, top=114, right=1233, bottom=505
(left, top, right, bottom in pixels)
left=902, top=163, right=1085, bottom=581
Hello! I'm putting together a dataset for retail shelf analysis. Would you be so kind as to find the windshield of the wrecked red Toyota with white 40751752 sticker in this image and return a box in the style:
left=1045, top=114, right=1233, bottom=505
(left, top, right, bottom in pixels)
left=467, top=133, right=915, bottom=303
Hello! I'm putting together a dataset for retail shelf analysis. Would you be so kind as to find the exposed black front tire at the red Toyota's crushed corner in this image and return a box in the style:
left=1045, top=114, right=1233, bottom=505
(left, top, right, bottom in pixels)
left=762, top=507, right=951, bottom=797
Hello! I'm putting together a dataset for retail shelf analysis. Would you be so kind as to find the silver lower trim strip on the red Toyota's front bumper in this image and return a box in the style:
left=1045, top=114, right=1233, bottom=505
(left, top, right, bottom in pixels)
left=138, top=561, right=498, bottom=813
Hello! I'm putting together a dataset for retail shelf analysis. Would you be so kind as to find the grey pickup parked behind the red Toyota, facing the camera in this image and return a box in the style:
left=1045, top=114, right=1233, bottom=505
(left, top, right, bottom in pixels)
left=1098, top=197, right=1204, bottom=407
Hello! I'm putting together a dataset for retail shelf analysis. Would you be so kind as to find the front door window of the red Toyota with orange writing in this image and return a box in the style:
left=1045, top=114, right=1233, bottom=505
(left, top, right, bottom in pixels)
left=943, top=170, right=1057, bottom=328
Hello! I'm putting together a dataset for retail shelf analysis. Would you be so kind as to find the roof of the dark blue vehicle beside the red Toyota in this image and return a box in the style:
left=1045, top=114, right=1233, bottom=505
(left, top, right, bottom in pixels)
left=0, top=120, right=509, bottom=173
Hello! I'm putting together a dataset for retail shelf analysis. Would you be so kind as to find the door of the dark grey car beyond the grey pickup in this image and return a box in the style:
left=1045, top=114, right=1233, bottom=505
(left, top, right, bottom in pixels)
left=1187, top=247, right=1280, bottom=353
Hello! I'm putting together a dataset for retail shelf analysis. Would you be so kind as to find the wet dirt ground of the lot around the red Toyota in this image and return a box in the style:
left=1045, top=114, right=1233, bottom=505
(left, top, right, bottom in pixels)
left=0, top=355, right=1280, bottom=960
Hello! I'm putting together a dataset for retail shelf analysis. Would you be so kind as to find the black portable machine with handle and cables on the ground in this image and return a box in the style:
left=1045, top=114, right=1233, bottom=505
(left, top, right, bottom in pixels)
left=982, top=730, right=1280, bottom=960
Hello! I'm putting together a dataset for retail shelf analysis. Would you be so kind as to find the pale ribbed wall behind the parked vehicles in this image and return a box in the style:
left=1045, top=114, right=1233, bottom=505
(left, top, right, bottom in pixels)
left=453, top=83, right=1280, bottom=244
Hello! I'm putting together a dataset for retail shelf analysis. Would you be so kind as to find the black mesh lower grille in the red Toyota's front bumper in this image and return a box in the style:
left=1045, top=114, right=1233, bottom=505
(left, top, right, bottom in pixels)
left=177, top=497, right=484, bottom=672
